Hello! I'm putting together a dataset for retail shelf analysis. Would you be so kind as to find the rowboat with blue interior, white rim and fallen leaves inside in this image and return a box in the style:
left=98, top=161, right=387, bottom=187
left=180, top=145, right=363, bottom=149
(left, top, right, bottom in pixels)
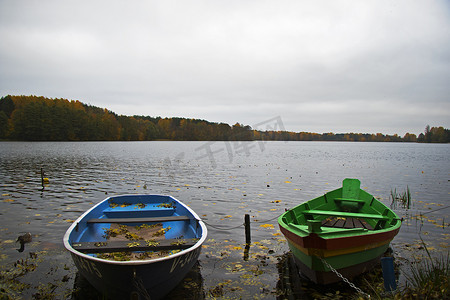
left=64, top=195, right=207, bottom=300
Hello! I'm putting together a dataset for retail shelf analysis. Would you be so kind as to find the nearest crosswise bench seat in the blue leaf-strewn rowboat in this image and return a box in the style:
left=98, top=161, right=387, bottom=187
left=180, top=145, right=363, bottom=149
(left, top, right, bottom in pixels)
left=72, top=239, right=198, bottom=253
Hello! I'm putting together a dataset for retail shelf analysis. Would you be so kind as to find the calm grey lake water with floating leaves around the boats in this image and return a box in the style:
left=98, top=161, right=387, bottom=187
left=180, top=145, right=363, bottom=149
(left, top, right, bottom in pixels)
left=0, top=141, right=450, bottom=299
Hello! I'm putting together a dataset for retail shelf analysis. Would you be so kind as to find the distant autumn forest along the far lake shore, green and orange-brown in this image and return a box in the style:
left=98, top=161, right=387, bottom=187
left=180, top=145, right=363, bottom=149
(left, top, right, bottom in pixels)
left=0, top=95, right=450, bottom=143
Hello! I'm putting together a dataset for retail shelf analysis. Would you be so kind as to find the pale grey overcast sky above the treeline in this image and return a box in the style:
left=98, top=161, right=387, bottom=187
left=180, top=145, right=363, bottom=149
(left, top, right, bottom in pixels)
left=0, top=0, right=450, bottom=135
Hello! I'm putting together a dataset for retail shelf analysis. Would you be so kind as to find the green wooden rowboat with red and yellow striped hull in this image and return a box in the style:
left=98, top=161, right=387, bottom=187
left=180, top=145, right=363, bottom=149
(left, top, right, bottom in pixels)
left=278, top=178, right=401, bottom=284
